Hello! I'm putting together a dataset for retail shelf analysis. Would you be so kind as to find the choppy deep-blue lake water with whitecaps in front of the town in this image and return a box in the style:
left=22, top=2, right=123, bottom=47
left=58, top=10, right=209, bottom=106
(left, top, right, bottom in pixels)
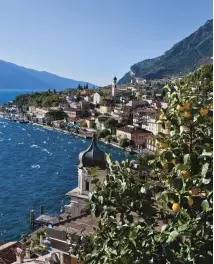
left=0, top=119, right=130, bottom=242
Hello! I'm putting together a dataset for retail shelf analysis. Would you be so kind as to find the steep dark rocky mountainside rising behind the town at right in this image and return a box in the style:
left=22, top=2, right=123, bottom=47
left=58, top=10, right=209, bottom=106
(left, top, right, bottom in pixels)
left=119, top=19, right=213, bottom=84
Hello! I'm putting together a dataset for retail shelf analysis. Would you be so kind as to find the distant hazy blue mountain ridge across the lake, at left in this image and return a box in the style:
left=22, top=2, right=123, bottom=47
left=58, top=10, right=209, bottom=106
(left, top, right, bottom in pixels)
left=0, top=60, right=97, bottom=91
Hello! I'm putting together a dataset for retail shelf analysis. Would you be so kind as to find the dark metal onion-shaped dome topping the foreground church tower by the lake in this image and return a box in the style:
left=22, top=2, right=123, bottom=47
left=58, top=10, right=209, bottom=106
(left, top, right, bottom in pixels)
left=79, top=136, right=106, bottom=169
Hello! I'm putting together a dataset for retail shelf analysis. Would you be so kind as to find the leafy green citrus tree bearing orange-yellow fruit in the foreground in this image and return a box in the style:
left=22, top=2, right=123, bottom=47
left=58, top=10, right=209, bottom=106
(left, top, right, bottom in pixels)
left=72, top=64, right=213, bottom=264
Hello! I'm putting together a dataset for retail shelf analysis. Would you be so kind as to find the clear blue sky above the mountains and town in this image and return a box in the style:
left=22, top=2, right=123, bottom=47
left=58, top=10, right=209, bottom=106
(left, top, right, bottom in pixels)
left=0, top=0, right=213, bottom=85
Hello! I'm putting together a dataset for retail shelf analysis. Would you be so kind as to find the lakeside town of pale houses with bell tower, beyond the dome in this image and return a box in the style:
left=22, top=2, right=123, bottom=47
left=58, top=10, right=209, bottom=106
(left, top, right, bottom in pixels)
left=1, top=75, right=173, bottom=154
